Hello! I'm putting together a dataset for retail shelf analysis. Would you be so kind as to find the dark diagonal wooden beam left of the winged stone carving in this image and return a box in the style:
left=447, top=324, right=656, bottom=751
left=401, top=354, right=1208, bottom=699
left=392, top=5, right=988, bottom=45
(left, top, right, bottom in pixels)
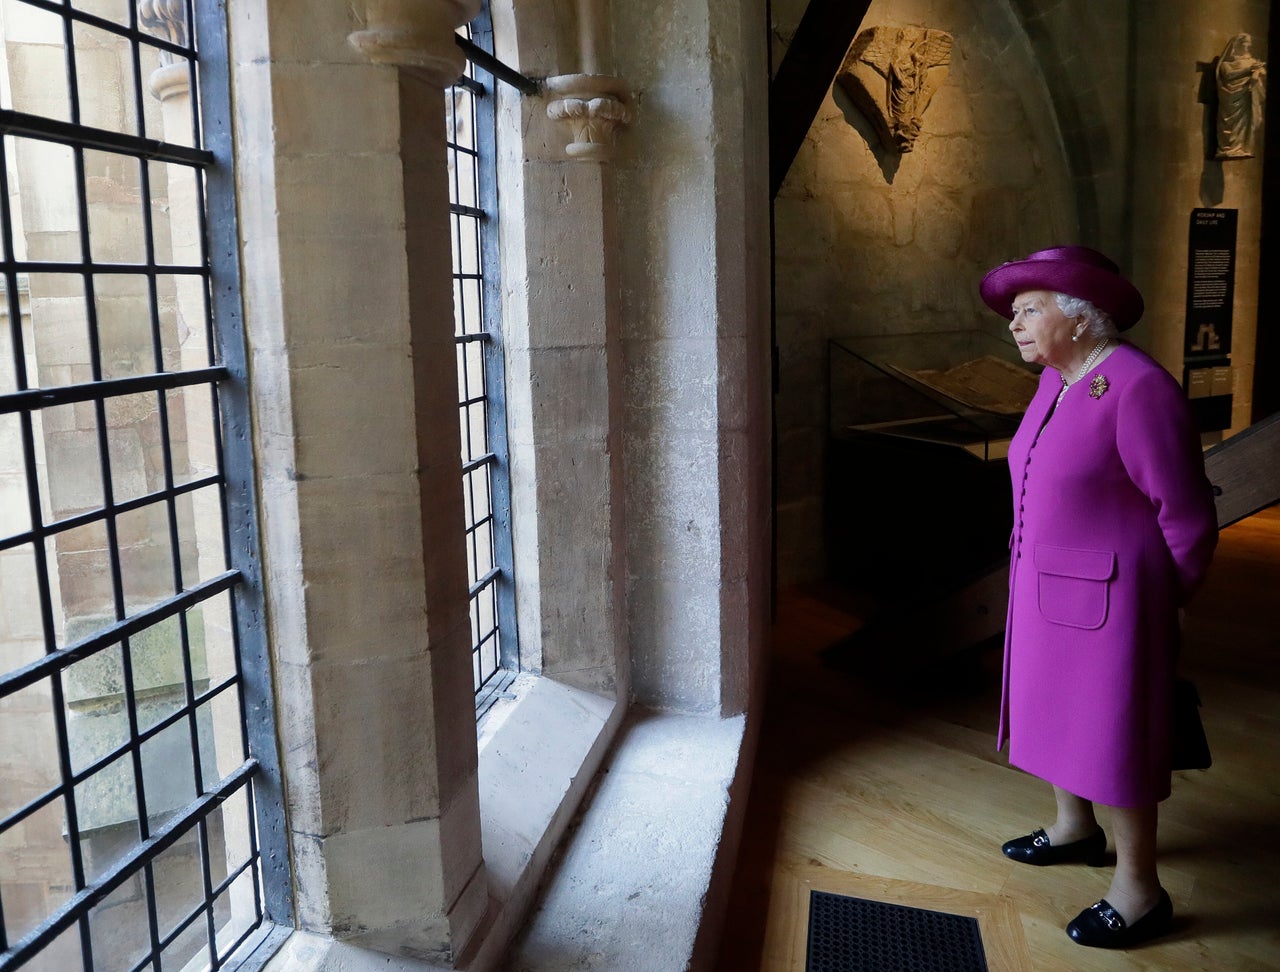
left=769, top=0, right=870, bottom=198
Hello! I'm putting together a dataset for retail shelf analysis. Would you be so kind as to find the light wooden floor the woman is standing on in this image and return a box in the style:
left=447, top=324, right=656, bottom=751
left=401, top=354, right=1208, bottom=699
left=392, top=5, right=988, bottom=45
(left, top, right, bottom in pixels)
left=717, top=507, right=1280, bottom=972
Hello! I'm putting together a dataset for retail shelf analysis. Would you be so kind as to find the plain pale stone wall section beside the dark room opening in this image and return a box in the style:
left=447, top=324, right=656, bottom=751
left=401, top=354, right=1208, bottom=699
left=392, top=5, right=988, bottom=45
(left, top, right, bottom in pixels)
left=613, top=0, right=768, bottom=711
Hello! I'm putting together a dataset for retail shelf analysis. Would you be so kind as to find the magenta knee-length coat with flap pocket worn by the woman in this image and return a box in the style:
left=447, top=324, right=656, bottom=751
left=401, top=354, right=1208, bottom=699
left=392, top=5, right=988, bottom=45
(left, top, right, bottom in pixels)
left=997, top=344, right=1217, bottom=807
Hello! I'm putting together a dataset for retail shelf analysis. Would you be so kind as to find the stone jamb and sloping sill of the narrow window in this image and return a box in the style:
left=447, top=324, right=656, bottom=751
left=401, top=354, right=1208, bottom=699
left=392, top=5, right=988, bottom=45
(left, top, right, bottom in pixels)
left=465, top=0, right=630, bottom=963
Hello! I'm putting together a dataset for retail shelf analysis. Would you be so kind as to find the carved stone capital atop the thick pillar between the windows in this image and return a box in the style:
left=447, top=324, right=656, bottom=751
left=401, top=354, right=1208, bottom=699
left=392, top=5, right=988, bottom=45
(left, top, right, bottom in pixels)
left=347, top=0, right=480, bottom=87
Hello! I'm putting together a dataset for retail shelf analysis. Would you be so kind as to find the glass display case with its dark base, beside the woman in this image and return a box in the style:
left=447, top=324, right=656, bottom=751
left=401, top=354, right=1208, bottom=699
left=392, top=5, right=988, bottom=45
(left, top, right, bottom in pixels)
left=823, top=330, right=1039, bottom=594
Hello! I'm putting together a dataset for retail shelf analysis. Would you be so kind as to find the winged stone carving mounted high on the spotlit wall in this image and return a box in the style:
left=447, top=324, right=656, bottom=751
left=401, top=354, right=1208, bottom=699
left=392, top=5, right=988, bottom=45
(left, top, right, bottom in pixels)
left=836, top=27, right=951, bottom=152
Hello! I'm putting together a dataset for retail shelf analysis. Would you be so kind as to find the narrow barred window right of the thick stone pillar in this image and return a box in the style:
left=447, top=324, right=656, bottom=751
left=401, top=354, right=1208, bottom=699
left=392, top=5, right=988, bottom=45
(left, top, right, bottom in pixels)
left=445, top=11, right=536, bottom=717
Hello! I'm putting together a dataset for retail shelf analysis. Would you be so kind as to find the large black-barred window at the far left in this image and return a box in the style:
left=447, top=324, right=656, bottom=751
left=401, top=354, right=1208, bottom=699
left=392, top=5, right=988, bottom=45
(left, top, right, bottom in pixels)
left=0, top=0, right=292, bottom=972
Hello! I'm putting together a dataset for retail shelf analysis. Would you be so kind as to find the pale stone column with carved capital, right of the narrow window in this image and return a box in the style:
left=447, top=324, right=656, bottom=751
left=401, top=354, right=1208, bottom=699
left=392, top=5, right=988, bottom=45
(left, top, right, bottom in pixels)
left=499, top=0, right=630, bottom=704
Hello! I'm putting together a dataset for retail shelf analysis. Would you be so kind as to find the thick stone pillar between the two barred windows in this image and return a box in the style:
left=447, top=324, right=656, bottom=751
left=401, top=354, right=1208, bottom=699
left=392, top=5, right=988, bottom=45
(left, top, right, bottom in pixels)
left=228, top=0, right=488, bottom=968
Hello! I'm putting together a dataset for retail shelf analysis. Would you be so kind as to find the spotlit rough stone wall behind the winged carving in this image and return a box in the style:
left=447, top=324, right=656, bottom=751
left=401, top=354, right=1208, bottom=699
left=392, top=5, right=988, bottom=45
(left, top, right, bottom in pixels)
left=773, top=0, right=1078, bottom=583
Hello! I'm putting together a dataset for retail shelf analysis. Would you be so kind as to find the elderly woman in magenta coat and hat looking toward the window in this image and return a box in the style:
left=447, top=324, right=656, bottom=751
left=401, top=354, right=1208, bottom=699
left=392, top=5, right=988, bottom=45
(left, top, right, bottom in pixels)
left=980, top=246, right=1217, bottom=948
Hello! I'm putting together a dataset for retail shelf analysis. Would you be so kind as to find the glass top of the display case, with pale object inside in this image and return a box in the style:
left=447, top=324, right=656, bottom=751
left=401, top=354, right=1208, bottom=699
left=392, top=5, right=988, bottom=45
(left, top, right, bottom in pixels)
left=828, top=330, right=1039, bottom=461
